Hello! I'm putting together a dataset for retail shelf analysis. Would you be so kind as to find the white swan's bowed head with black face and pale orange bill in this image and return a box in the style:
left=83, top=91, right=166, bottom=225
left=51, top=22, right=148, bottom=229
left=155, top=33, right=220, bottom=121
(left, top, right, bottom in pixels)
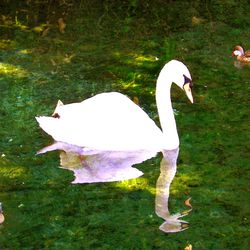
left=165, top=60, right=194, bottom=103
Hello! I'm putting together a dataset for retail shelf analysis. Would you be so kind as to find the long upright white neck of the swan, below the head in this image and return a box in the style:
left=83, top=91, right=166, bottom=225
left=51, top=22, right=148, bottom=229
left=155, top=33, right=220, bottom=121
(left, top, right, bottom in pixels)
left=156, top=74, right=179, bottom=150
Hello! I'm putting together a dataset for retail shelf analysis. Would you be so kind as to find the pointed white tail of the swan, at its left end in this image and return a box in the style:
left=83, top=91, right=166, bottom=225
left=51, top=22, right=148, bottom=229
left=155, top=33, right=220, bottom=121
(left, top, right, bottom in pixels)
left=36, top=116, right=60, bottom=140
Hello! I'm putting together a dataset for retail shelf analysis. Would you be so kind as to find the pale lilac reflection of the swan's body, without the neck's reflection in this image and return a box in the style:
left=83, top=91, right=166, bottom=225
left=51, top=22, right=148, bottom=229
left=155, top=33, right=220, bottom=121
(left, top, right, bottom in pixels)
left=37, top=141, right=149, bottom=183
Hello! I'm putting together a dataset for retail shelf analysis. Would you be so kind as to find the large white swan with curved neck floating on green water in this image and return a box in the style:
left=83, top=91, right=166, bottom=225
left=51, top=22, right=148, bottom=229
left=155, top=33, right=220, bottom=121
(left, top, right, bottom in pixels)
left=36, top=60, right=193, bottom=183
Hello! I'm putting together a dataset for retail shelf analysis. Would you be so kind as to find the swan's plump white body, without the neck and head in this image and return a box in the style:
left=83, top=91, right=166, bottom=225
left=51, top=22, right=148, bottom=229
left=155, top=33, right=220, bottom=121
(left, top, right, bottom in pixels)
left=37, top=92, right=163, bottom=151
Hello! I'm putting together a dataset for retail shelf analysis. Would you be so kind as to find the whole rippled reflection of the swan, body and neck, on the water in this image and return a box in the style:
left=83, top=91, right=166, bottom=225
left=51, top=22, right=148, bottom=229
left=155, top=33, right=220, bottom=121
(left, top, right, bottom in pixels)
left=39, top=142, right=192, bottom=233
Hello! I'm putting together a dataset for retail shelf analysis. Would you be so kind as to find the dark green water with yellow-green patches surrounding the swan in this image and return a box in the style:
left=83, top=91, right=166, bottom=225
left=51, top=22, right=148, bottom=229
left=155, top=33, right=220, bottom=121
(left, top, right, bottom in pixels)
left=0, top=0, right=250, bottom=249
